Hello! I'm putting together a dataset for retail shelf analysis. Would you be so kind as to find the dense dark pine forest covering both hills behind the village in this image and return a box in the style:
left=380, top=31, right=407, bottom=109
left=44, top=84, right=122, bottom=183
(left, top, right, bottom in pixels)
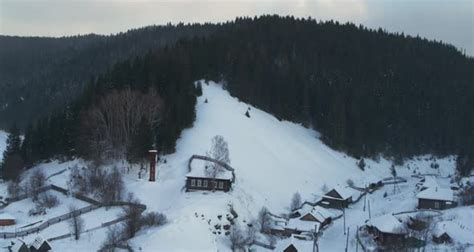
left=0, top=16, right=474, bottom=174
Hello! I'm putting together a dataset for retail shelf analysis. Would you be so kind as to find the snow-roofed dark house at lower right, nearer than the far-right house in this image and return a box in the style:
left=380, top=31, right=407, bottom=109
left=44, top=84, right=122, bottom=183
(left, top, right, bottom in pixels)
left=366, top=214, right=408, bottom=245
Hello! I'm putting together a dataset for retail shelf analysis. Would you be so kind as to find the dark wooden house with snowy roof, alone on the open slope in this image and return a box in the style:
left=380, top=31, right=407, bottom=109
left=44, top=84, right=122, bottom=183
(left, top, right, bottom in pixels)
left=186, top=155, right=235, bottom=192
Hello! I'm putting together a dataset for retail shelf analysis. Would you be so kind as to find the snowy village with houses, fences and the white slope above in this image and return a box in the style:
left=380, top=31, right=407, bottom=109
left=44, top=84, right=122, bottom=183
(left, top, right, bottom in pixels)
left=0, top=83, right=474, bottom=252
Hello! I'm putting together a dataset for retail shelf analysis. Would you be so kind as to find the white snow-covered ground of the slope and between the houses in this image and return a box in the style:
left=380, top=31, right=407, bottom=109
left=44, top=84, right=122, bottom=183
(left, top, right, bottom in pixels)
left=0, top=82, right=472, bottom=251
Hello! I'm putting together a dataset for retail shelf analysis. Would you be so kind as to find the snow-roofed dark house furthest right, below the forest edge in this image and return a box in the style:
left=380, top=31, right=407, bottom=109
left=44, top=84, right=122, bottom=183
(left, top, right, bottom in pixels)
left=416, top=187, right=456, bottom=209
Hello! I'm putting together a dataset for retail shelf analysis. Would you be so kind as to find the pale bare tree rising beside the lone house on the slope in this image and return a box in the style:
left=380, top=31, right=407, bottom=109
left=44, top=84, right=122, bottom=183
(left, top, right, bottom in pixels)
left=206, top=135, right=230, bottom=178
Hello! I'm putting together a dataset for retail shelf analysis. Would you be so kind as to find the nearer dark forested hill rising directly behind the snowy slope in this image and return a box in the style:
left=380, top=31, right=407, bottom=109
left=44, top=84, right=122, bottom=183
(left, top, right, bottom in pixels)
left=3, top=16, right=474, bottom=175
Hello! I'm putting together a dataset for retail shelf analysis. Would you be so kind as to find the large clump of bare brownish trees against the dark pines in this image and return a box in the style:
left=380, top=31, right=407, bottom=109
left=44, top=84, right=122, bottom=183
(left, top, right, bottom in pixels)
left=81, top=89, right=163, bottom=162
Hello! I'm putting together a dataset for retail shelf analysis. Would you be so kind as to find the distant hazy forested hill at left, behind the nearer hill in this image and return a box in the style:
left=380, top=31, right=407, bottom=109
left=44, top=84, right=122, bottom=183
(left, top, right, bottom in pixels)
left=0, top=24, right=216, bottom=128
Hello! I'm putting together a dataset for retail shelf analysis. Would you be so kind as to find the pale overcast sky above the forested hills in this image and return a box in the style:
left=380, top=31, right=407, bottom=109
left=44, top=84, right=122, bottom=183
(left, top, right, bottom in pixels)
left=0, top=0, right=474, bottom=55
